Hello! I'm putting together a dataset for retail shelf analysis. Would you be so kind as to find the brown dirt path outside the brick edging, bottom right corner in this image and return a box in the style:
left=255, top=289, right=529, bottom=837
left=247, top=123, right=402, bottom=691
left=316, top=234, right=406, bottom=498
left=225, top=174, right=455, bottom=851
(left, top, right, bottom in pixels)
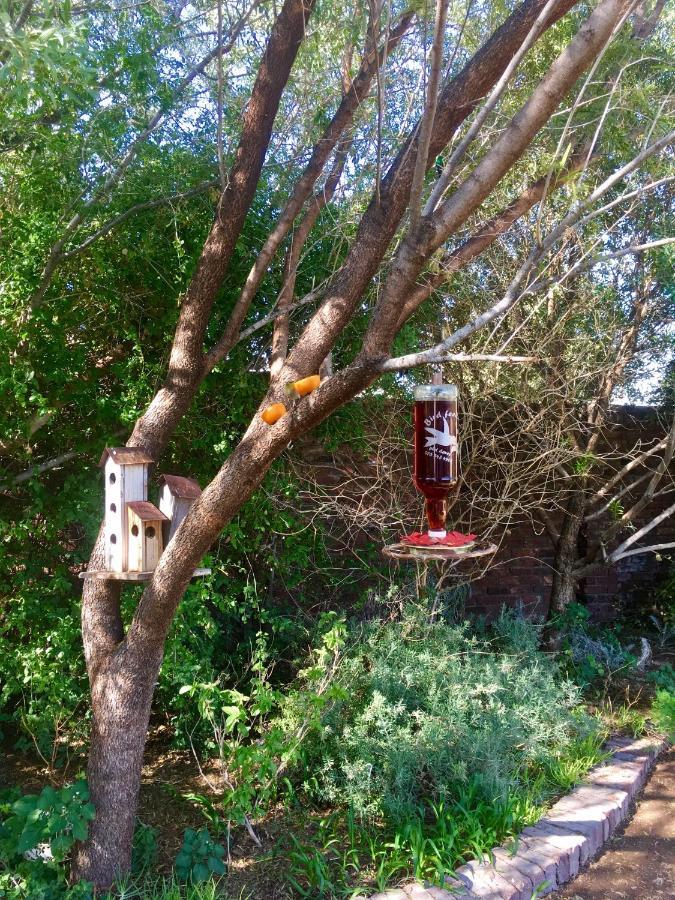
left=554, top=750, right=675, bottom=900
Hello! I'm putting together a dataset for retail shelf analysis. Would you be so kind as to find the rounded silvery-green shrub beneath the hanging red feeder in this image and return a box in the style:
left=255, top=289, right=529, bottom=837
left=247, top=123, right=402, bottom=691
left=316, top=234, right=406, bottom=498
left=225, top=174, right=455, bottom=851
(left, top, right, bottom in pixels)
left=298, top=614, right=594, bottom=821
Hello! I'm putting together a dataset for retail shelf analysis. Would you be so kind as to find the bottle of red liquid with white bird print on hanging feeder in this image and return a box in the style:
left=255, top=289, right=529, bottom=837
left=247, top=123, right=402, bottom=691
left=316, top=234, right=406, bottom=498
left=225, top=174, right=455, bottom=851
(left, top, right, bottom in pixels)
left=413, top=385, right=457, bottom=537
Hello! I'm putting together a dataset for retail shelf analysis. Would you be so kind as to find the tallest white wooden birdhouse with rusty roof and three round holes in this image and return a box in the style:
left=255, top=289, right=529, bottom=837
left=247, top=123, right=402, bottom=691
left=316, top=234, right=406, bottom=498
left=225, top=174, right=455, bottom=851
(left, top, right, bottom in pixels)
left=99, top=447, right=152, bottom=572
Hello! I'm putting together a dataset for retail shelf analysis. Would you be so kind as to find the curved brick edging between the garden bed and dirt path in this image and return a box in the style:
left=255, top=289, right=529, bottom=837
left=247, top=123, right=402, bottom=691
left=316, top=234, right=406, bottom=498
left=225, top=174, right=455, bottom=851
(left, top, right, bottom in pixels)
left=362, top=738, right=667, bottom=900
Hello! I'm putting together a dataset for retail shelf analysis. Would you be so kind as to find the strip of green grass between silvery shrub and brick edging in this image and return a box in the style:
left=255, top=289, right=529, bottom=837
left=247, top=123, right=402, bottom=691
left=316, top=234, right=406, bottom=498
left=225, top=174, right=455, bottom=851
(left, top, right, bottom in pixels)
left=274, top=734, right=607, bottom=898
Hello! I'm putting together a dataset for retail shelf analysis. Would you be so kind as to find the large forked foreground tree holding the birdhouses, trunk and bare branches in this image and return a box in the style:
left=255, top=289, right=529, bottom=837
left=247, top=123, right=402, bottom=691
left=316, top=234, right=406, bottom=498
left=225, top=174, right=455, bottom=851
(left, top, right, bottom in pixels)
left=6, top=0, right=672, bottom=887
